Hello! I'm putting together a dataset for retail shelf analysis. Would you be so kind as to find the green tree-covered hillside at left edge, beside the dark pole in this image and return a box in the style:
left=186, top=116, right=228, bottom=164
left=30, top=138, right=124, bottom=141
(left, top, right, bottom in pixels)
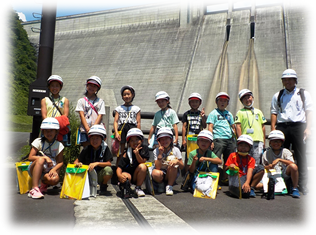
left=0, top=4, right=36, bottom=115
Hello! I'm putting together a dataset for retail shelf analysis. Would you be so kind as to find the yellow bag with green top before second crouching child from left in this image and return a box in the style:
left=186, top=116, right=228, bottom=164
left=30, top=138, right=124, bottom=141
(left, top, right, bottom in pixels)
left=60, top=164, right=90, bottom=200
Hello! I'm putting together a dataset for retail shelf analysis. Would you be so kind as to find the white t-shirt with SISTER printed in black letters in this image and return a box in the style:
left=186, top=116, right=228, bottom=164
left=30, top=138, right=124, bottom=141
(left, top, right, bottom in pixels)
left=115, top=105, right=140, bottom=126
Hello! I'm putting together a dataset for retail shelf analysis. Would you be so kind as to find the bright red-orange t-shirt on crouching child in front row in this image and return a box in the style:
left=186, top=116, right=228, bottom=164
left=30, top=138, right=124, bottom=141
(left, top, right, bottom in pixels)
left=225, top=152, right=256, bottom=177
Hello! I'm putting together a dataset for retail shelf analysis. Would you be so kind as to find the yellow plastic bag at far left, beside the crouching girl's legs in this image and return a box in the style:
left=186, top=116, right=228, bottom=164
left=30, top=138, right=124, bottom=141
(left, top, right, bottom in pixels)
left=15, top=162, right=32, bottom=194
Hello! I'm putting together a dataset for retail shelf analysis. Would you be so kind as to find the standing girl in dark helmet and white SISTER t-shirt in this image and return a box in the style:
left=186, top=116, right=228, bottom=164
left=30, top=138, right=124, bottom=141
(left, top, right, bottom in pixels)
left=113, top=86, right=141, bottom=166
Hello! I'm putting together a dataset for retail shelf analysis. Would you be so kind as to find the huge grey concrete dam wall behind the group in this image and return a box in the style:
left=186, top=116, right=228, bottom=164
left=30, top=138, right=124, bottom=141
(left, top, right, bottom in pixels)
left=23, top=0, right=316, bottom=129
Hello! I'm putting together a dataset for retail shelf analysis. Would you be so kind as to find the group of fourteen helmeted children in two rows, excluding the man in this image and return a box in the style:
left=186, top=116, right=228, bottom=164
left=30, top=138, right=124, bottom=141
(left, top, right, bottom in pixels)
left=25, top=75, right=300, bottom=198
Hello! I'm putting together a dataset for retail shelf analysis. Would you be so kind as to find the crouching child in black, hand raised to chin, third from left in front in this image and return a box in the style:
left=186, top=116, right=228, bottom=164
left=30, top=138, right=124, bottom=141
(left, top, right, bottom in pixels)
left=116, top=128, right=149, bottom=198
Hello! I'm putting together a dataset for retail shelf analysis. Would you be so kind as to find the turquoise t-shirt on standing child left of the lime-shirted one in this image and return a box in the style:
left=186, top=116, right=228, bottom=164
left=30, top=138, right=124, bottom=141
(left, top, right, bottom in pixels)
left=206, top=109, right=234, bottom=139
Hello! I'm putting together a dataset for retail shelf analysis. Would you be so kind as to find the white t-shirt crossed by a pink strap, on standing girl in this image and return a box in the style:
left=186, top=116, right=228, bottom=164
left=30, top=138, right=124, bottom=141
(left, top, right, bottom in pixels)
left=75, top=97, right=105, bottom=133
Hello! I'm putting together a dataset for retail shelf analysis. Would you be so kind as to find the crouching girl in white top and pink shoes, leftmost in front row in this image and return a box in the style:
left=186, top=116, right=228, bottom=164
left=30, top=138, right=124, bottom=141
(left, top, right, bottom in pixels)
left=28, top=118, right=64, bottom=199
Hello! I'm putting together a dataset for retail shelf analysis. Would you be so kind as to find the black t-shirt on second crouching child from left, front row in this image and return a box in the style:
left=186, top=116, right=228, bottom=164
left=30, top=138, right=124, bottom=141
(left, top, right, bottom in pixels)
left=78, top=145, right=113, bottom=171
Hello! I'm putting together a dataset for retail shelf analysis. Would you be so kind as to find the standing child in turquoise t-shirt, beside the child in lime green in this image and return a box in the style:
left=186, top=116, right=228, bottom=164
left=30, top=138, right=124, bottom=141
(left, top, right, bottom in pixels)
left=206, top=92, right=236, bottom=185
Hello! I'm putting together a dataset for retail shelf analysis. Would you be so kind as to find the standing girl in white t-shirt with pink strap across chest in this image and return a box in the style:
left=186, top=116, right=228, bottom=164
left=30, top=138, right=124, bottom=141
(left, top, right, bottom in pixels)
left=75, top=76, right=105, bottom=147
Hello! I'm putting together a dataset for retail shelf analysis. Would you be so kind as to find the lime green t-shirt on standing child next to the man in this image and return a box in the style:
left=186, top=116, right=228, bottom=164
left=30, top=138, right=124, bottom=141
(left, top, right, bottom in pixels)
left=235, top=108, right=267, bottom=142
